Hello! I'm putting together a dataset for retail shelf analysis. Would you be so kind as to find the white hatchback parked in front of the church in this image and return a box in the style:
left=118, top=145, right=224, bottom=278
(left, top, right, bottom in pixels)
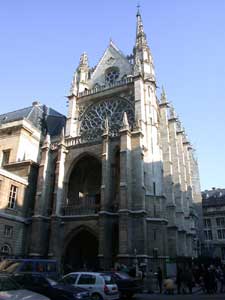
left=62, top=272, right=119, bottom=300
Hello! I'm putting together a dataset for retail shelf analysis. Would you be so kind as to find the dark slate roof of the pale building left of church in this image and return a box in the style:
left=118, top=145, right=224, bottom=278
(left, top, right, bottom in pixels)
left=0, top=105, right=66, bottom=136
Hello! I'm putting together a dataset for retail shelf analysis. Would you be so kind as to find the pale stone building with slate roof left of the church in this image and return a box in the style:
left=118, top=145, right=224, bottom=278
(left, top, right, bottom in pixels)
left=0, top=102, right=65, bottom=258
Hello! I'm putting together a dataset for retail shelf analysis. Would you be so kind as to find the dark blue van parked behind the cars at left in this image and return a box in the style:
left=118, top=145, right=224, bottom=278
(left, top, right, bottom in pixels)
left=0, top=258, right=59, bottom=278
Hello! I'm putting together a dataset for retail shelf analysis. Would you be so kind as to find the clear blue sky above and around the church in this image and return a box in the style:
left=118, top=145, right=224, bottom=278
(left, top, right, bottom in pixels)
left=0, top=0, right=225, bottom=190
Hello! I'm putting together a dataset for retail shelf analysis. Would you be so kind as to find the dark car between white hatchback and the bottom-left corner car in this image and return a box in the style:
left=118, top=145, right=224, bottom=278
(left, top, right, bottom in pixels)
left=12, top=273, right=91, bottom=300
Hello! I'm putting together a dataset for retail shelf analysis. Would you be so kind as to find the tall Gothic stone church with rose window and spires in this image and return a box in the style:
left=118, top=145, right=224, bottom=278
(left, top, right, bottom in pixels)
left=29, top=11, right=201, bottom=270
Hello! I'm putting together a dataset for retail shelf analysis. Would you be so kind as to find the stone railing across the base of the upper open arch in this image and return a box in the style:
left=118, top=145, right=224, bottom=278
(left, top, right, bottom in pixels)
left=62, top=196, right=100, bottom=216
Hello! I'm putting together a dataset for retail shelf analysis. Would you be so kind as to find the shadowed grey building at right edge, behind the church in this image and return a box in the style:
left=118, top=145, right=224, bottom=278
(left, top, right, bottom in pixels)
left=202, top=188, right=225, bottom=262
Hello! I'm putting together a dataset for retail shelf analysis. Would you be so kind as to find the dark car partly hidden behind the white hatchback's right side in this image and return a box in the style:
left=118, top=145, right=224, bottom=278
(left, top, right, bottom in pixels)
left=104, top=271, right=143, bottom=298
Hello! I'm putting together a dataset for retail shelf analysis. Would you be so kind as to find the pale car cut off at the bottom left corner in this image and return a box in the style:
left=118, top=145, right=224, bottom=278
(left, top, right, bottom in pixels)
left=0, top=274, right=49, bottom=300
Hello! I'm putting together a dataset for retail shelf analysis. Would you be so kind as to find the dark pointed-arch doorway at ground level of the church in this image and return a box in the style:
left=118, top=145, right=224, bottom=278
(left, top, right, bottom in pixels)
left=64, top=228, right=98, bottom=272
